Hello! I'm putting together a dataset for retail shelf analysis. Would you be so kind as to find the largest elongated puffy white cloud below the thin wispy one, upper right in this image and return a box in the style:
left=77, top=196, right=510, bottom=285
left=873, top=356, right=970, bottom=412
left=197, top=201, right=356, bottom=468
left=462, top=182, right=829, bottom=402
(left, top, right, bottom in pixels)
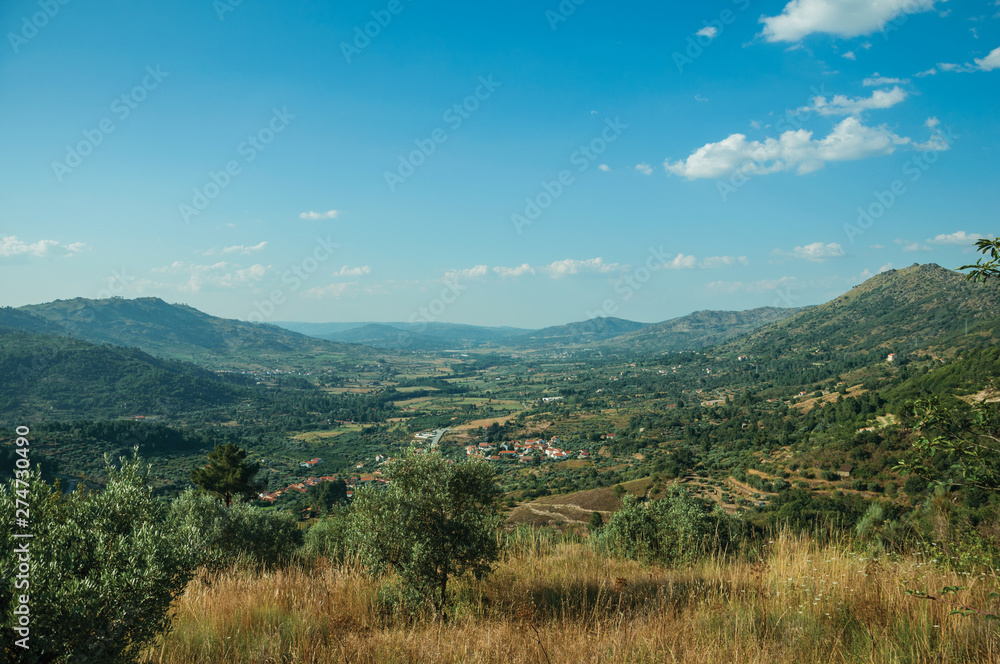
left=663, top=117, right=910, bottom=180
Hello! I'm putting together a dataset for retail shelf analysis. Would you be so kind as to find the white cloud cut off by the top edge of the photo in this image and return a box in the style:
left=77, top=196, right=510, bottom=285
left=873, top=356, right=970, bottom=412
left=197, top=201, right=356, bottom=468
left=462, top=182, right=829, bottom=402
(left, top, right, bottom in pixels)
left=760, top=0, right=935, bottom=42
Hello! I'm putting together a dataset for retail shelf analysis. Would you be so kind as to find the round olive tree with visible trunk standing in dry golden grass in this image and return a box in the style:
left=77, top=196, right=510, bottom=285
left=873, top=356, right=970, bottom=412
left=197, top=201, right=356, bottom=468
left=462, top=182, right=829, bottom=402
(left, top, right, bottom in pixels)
left=353, top=449, right=502, bottom=618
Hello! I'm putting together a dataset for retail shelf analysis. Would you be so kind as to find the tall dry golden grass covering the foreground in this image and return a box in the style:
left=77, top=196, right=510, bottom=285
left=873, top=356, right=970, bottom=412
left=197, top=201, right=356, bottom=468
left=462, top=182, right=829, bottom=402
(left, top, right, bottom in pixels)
left=146, top=534, right=1000, bottom=664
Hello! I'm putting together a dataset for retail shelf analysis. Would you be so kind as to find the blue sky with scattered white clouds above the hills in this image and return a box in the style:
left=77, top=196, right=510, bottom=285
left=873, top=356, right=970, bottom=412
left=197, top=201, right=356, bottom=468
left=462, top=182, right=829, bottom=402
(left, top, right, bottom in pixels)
left=0, top=0, right=1000, bottom=327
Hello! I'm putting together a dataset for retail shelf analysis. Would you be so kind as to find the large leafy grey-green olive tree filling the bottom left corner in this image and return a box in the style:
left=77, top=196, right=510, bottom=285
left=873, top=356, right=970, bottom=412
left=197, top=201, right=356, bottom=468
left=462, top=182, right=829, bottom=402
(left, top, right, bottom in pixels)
left=0, top=457, right=194, bottom=664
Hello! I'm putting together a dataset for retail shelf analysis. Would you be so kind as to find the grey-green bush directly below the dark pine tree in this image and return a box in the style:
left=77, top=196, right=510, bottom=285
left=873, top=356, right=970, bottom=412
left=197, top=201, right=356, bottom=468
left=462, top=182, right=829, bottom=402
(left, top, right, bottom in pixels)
left=168, top=490, right=302, bottom=571
